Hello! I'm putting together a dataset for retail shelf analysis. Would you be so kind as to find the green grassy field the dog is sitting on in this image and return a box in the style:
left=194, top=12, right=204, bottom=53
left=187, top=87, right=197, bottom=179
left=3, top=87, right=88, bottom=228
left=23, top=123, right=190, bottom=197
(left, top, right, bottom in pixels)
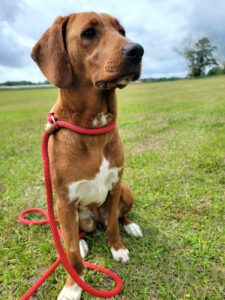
left=0, top=77, right=225, bottom=300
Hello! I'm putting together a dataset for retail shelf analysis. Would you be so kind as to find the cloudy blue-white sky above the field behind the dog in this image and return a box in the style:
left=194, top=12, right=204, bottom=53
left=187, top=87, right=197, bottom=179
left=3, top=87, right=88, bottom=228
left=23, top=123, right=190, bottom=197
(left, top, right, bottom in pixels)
left=0, top=0, right=225, bottom=82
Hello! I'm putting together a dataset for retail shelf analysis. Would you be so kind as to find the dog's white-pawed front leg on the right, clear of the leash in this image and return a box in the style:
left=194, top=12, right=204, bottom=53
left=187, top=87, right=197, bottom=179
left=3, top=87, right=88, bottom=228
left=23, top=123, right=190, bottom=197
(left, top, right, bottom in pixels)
left=106, top=182, right=129, bottom=263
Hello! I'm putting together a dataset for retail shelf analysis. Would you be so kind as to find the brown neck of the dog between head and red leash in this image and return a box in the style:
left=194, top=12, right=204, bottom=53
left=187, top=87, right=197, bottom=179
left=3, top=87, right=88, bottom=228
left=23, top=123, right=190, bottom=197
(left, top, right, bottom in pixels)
left=55, top=87, right=117, bottom=128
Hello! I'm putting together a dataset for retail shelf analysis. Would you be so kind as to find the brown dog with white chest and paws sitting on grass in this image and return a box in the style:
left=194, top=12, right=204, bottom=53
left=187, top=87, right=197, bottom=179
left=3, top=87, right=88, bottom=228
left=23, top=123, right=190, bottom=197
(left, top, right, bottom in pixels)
left=32, top=12, right=144, bottom=300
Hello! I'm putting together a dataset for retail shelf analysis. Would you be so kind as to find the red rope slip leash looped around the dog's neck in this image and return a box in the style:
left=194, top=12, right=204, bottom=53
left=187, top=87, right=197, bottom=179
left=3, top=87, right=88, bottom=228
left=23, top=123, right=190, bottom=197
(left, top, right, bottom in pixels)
left=19, top=114, right=122, bottom=300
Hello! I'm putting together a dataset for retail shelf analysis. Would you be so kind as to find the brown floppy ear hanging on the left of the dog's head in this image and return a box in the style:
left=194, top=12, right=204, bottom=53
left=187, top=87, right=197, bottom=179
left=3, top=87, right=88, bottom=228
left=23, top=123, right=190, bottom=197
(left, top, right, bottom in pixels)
left=31, top=16, right=72, bottom=88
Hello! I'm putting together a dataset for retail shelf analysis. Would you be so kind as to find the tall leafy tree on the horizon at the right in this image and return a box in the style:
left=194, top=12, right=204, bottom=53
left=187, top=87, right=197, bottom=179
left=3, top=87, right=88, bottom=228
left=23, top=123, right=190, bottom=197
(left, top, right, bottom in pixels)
left=181, top=37, right=218, bottom=77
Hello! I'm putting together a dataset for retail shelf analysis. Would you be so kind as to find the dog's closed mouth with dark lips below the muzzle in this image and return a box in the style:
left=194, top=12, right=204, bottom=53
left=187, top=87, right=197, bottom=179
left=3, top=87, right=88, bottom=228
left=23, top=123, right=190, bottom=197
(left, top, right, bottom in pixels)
left=95, top=72, right=139, bottom=89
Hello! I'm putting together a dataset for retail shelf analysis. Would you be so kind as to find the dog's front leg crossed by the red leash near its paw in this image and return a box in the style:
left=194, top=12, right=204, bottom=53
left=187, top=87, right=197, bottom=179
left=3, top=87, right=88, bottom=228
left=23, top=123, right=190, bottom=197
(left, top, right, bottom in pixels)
left=57, top=199, right=83, bottom=300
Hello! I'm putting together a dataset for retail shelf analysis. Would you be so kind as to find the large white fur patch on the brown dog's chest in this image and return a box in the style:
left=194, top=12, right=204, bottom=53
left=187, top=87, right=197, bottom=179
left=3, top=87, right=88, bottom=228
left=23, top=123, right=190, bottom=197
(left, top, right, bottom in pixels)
left=68, top=158, right=122, bottom=209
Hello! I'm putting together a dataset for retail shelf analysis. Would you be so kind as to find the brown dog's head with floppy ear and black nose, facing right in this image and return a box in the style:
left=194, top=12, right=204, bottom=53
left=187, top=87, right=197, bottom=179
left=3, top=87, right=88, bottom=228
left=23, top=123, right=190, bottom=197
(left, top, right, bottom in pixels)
left=31, top=12, right=144, bottom=89
